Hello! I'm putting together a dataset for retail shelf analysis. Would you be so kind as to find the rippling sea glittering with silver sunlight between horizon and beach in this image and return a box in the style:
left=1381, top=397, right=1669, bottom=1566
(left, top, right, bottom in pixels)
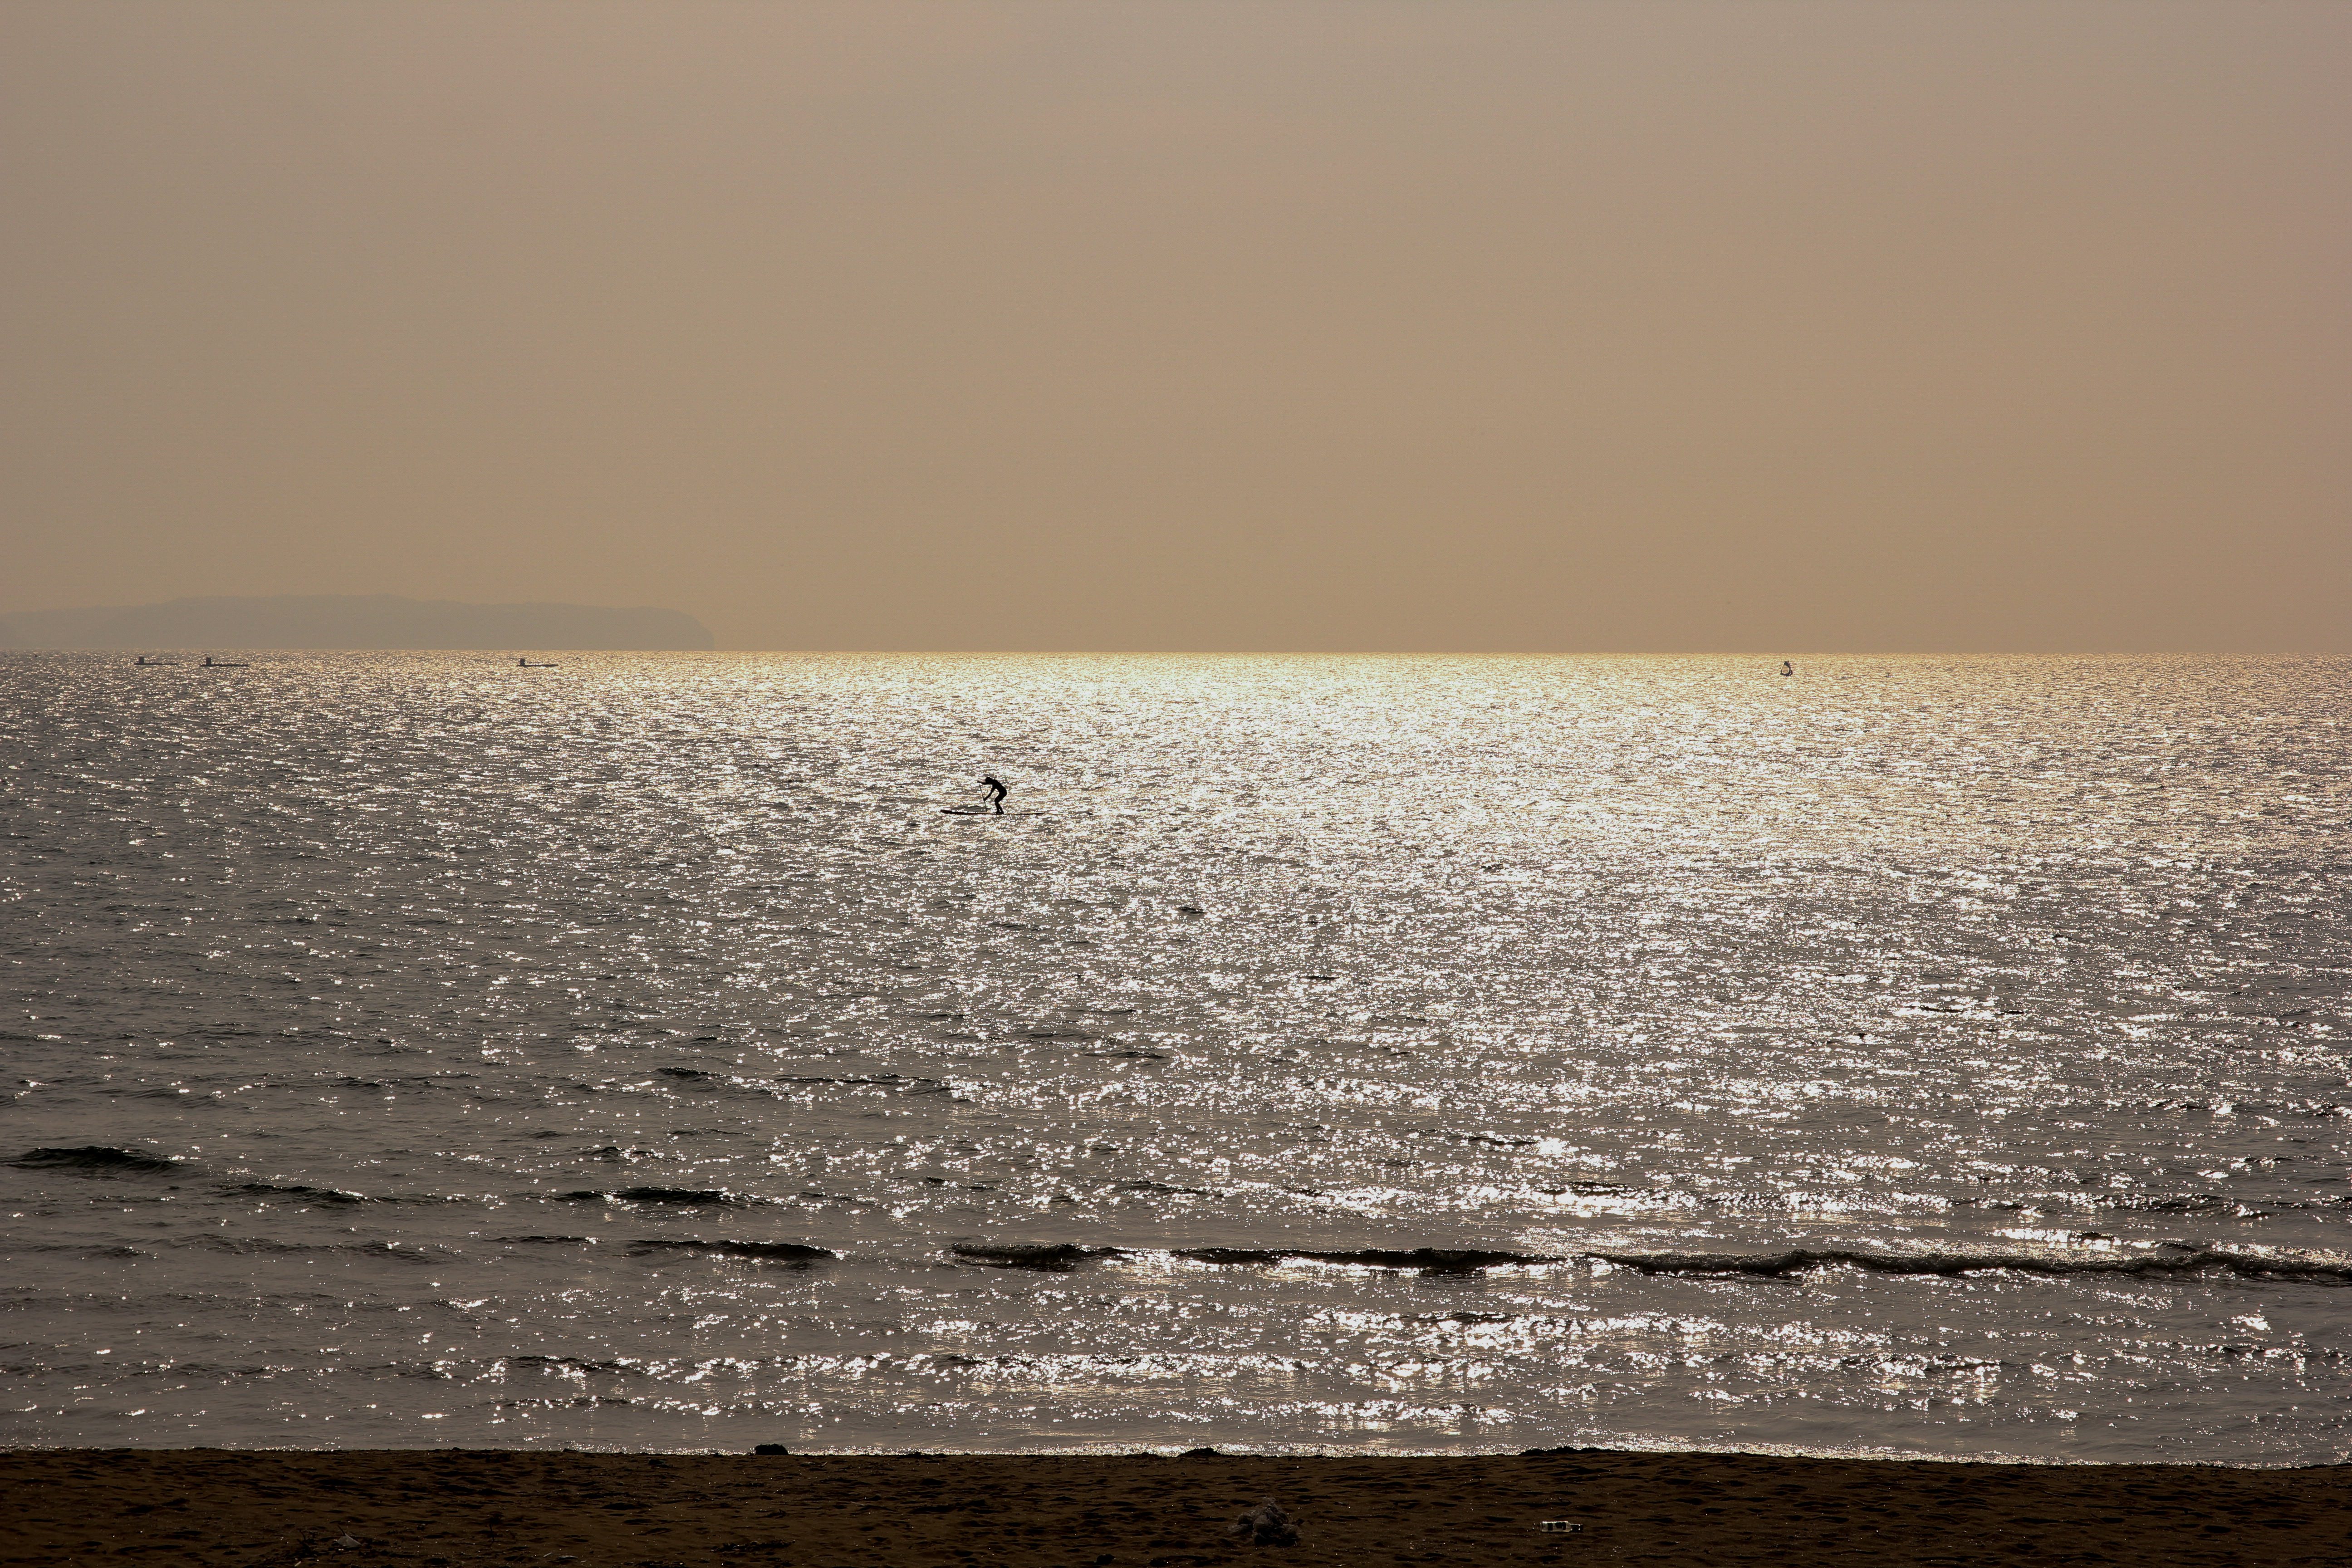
left=0, top=653, right=2352, bottom=1465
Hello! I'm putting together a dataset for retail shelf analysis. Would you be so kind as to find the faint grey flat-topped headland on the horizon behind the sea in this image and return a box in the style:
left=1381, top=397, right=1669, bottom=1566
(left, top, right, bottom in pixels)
left=0, top=593, right=717, bottom=651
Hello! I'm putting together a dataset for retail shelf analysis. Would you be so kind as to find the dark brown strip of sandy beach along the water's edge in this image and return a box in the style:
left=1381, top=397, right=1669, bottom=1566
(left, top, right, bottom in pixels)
left=0, top=1448, right=2352, bottom=1568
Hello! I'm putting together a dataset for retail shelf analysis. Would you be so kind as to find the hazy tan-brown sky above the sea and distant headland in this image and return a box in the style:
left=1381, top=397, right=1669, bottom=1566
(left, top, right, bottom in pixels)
left=0, top=0, right=2352, bottom=651
